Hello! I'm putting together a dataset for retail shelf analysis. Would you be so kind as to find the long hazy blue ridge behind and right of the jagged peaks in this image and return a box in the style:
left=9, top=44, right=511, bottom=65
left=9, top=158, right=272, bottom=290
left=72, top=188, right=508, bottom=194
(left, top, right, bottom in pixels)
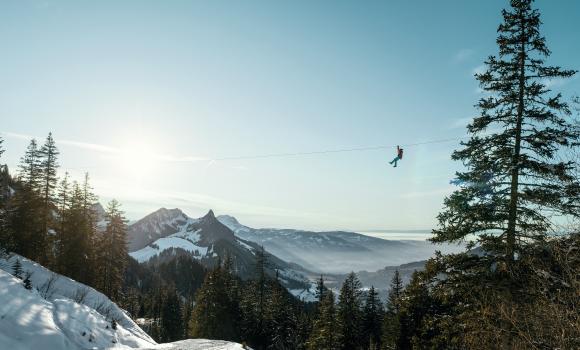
left=217, top=215, right=463, bottom=273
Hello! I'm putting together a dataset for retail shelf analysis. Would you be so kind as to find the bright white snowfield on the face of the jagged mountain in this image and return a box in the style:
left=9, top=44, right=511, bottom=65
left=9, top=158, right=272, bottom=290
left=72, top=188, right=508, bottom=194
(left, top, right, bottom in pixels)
left=129, top=230, right=208, bottom=263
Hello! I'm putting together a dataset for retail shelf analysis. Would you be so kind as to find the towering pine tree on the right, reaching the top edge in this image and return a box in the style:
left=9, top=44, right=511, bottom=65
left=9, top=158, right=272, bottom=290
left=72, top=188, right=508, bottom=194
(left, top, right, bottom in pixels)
left=433, top=0, right=580, bottom=267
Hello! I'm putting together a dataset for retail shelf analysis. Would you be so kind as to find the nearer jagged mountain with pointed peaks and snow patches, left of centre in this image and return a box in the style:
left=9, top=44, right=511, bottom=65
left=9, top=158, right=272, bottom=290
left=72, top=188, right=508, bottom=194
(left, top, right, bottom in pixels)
left=129, top=208, right=312, bottom=299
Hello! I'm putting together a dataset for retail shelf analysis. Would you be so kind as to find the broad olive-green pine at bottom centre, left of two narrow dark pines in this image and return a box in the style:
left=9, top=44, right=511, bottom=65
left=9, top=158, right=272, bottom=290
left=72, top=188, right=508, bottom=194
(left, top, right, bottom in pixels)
left=308, top=292, right=343, bottom=350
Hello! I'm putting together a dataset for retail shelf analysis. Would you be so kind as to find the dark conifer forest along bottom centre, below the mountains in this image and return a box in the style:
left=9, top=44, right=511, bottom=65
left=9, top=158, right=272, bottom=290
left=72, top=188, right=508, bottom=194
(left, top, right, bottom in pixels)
left=187, top=247, right=403, bottom=349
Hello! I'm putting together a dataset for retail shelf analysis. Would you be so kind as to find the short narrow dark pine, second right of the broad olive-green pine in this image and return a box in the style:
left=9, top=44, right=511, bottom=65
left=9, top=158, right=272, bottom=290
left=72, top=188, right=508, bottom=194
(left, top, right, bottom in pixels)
left=362, top=286, right=384, bottom=350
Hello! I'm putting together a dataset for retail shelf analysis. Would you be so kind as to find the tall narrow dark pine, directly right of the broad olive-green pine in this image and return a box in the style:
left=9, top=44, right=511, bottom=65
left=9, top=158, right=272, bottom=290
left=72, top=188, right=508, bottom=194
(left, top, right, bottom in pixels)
left=337, top=272, right=363, bottom=350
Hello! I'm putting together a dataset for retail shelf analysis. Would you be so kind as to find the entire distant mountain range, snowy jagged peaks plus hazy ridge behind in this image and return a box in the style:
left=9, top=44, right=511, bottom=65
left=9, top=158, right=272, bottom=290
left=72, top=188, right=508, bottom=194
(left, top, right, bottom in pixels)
left=128, top=208, right=463, bottom=299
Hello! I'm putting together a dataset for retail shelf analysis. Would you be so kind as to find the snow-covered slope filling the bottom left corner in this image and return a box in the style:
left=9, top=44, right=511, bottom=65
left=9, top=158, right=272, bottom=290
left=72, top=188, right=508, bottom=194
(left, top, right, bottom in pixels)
left=0, top=254, right=156, bottom=350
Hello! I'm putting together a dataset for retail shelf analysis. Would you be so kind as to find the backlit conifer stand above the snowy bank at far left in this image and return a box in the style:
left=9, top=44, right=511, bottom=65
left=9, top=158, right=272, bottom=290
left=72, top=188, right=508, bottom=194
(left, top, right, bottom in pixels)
left=0, top=134, right=127, bottom=301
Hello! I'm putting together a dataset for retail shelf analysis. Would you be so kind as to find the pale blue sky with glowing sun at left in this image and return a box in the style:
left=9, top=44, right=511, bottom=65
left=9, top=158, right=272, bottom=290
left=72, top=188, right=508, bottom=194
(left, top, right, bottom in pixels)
left=0, top=0, right=580, bottom=231
